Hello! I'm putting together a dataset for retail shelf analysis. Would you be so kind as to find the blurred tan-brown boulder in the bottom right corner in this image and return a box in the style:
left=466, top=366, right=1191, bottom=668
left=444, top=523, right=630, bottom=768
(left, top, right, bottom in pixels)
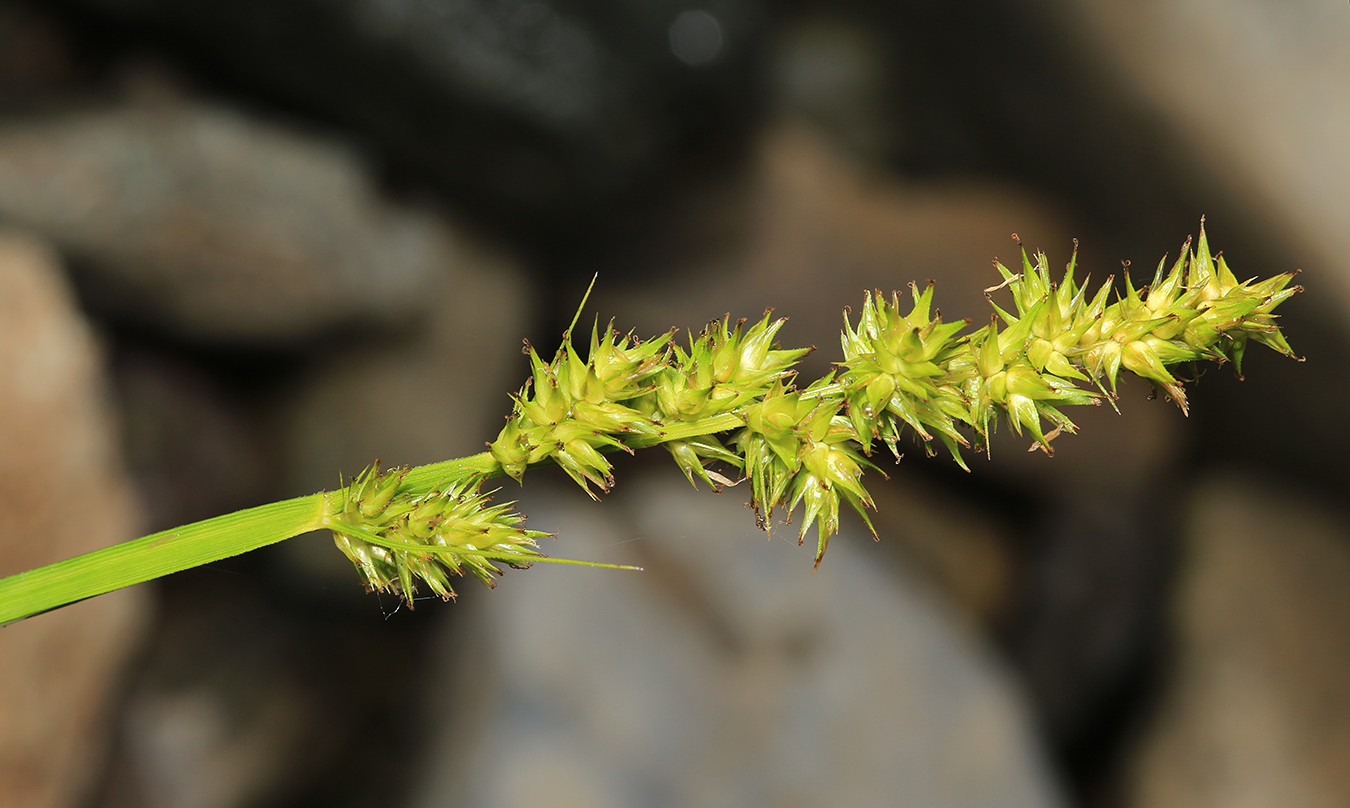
left=1126, top=472, right=1350, bottom=808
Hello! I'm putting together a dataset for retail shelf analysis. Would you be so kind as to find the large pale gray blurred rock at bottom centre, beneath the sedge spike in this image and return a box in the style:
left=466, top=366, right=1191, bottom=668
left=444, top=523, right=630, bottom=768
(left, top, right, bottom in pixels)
left=414, top=469, right=1061, bottom=807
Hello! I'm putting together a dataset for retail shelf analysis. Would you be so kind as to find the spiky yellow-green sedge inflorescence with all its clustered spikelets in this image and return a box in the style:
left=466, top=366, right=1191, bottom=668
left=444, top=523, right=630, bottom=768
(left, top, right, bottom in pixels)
left=324, top=221, right=1300, bottom=598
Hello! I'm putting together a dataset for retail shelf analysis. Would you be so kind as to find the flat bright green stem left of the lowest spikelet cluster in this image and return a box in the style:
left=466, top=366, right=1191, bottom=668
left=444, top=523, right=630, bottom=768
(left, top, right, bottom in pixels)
left=0, top=494, right=327, bottom=626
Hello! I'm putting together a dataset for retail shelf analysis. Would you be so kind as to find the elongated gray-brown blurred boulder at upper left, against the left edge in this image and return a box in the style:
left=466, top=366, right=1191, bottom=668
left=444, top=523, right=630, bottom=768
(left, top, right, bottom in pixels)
left=0, top=93, right=450, bottom=343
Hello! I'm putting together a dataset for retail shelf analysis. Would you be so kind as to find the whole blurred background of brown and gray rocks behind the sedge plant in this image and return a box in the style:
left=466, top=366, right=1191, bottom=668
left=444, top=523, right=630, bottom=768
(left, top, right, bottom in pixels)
left=0, top=0, right=1350, bottom=808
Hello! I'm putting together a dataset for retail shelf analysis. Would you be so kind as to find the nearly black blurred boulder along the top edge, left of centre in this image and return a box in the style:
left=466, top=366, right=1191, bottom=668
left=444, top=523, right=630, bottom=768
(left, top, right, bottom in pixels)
left=44, top=0, right=763, bottom=239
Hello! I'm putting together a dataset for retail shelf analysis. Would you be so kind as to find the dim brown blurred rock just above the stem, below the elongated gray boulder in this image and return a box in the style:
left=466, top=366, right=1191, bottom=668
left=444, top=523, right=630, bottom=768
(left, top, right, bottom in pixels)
left=286, top=227, right=535, bottom=491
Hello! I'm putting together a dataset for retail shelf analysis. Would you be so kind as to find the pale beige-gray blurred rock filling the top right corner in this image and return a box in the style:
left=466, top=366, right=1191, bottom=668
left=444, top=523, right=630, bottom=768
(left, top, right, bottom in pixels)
left=1046, top=0, right=1350, bottom=309
